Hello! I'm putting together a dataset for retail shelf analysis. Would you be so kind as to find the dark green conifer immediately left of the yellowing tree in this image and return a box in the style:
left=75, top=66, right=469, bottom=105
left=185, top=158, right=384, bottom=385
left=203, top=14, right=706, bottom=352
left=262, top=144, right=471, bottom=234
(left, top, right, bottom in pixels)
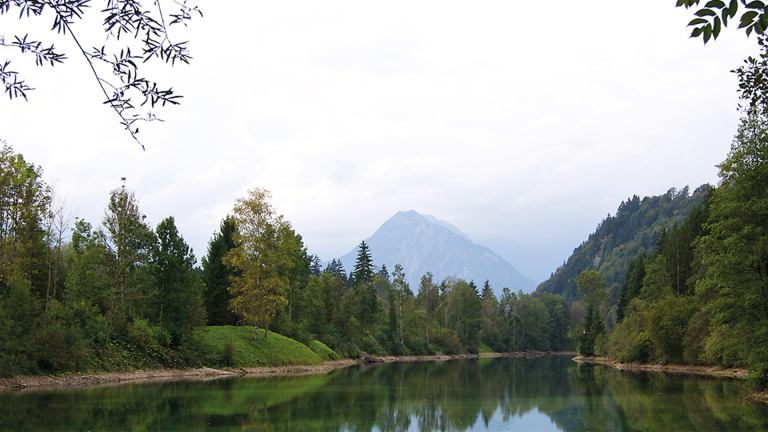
left=202, top=216, right=237, bottom=326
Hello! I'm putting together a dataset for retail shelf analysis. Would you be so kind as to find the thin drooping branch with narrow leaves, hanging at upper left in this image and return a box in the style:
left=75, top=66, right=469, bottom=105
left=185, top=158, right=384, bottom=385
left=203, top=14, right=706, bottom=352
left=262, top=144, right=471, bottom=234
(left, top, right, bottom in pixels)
left=0, top=0, right=202, bottom=148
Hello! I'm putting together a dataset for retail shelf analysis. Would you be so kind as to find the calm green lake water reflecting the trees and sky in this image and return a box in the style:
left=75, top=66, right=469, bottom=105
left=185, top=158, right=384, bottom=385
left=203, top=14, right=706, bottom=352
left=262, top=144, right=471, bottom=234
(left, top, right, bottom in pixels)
left=0, top=356, right=768, bottom=432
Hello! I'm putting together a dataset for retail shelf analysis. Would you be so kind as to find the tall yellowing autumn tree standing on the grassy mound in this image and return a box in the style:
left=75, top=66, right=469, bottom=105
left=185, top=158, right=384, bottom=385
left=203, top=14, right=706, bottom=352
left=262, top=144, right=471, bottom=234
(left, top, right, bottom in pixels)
left=223, top=188, right=300, bottom=339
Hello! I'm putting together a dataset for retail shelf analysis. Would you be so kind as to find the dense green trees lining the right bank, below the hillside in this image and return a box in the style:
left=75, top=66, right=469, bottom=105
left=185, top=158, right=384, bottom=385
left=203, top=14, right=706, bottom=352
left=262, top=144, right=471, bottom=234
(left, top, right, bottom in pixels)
left=576, top=50, right=768, bottom=387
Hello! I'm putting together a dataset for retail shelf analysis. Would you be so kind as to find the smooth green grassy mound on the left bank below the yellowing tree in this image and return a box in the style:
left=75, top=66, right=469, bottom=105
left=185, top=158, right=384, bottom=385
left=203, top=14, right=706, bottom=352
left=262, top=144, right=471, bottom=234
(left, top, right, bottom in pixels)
left=198, top=326, right=328, bottom=367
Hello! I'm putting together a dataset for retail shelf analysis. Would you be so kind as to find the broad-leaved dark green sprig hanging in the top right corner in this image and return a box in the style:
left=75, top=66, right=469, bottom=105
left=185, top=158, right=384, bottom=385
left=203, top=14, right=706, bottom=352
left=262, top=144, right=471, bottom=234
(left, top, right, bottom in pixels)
left=676, top=0, right=768, bottom=43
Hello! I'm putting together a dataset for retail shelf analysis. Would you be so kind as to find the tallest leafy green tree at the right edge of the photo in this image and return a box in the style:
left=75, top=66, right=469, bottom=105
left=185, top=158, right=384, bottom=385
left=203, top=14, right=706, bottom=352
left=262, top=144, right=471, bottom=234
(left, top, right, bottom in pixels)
left=696, top=112, right=768, bottom=378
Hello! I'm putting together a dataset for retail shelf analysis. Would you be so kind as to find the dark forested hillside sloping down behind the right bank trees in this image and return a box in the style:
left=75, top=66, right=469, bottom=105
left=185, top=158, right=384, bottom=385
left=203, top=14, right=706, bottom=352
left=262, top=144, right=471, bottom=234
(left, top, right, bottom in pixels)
left=536, top=184, right=711, bottom=305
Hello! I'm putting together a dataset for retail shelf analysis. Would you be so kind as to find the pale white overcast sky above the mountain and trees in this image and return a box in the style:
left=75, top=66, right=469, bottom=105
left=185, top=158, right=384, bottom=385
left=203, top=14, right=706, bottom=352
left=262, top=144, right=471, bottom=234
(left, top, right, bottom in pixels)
left=0, top=0, right=759, bottom=282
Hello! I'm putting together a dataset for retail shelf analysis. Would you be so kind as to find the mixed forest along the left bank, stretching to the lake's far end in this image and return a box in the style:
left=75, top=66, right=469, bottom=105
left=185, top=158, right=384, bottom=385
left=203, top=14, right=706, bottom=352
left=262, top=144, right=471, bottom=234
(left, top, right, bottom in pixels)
left=0, top=159, right=573, bottom=377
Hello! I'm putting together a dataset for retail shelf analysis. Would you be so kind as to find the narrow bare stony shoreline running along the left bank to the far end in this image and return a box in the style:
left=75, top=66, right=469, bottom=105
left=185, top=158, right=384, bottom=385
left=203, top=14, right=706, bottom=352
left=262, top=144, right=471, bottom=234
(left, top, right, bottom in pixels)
left=0, top=351, right=575, bottom=392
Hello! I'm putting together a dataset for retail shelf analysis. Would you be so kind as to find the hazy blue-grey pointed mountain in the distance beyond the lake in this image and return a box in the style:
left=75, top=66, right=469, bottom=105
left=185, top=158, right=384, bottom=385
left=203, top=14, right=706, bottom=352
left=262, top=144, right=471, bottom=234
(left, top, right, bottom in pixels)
left=340, top=210, right=536, bottom=296
